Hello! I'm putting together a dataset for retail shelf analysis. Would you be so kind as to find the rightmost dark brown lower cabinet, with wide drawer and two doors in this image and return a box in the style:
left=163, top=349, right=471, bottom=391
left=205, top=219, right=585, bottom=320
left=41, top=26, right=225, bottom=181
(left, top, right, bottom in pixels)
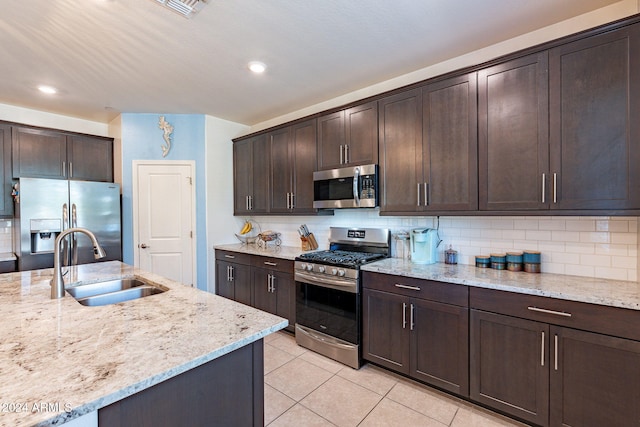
left=469, top=288, right=640, bottom=427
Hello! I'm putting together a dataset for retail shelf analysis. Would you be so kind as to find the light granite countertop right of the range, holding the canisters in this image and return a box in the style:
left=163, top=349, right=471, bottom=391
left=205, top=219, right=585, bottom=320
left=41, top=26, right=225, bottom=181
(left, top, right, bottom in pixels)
left=362, top=258, right=640, bottom=310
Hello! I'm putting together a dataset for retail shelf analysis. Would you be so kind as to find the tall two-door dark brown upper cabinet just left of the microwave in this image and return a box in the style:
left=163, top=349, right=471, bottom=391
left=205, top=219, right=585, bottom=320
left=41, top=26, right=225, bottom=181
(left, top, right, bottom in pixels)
left=269, top=119, right=316, bottom=213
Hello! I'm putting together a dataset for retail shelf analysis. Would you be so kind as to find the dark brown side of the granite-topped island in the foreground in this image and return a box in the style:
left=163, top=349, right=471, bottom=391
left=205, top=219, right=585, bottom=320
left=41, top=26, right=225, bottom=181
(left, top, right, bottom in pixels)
left=98, top=340, right=264, bottom=427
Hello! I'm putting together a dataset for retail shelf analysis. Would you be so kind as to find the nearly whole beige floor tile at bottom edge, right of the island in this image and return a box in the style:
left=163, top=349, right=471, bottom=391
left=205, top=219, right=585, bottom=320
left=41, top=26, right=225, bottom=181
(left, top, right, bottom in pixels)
left=300, top=376, right=382, bottom=427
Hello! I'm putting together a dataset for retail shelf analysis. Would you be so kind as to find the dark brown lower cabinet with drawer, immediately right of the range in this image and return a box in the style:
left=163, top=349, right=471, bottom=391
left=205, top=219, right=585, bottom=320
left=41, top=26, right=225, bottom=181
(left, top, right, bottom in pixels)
left=362, top=272, right=469, bottom=396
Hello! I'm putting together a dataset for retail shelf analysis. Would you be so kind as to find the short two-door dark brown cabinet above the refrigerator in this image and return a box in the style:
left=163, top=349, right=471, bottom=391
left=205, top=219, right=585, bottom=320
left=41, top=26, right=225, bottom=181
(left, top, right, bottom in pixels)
left=12, top=126, right=113, bottom=182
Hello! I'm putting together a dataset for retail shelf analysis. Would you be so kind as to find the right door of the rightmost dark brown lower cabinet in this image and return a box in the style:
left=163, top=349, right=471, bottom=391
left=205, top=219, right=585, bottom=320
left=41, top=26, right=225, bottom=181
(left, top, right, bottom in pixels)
left=550, top=327, right=640, bottom=427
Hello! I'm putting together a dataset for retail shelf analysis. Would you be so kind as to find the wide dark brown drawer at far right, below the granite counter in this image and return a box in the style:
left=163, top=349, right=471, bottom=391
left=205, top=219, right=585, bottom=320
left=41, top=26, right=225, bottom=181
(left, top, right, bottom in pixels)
left=469, top=287, right=640, bottom=340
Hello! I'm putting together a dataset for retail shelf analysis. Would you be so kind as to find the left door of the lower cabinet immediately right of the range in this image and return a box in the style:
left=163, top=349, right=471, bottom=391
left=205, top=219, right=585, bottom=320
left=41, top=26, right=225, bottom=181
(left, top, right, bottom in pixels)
left=362, top=289, right=410, bottom=374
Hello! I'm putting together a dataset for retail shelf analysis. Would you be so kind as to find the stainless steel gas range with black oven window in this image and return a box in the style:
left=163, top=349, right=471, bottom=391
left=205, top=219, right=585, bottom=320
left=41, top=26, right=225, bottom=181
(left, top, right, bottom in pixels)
left=294, top=227, right=391, bottom=369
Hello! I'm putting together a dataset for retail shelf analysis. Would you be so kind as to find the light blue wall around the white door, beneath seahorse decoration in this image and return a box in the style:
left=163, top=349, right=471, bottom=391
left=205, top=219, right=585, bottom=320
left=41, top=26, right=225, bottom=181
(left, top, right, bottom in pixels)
left=122, top=113, right=207, bottom=290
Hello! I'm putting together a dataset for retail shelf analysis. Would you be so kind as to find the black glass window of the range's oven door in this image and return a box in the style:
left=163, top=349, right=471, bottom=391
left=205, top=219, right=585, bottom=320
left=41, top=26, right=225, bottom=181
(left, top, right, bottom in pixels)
left=296, top=282, right=360, bottom=344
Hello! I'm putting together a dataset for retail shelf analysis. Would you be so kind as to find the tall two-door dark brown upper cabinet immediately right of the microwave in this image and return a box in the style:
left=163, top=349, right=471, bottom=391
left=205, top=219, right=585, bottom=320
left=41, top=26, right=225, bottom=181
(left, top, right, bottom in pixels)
left=379, top=73, right=478, bottom=214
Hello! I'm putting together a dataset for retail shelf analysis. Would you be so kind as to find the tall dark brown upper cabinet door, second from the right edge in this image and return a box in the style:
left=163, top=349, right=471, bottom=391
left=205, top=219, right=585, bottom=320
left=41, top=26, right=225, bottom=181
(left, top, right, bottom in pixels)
left=478, top=52, right=549, bottom=211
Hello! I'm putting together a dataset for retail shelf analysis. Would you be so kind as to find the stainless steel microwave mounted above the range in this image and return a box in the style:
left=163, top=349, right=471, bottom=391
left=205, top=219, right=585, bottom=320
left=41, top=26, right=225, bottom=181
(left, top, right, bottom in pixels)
left=313, top=165, right=378, bottom=209
